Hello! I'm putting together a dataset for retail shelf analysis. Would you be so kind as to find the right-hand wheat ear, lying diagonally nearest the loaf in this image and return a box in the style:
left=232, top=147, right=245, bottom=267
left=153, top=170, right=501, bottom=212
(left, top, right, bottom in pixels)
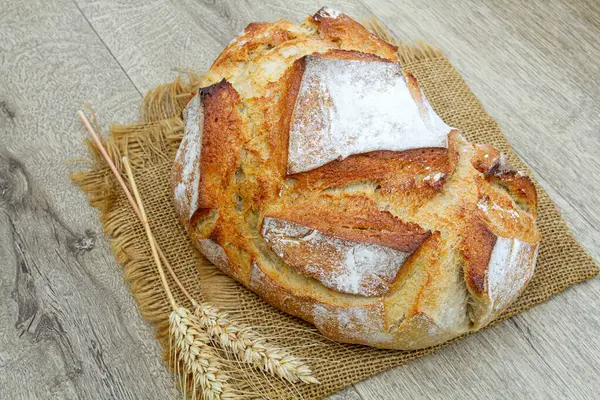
left=194, top=303, right=319, bottom=383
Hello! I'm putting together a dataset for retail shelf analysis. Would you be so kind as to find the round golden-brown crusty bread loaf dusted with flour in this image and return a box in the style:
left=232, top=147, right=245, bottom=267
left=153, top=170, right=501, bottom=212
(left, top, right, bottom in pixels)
left=172, top=9, right=540, bottom=349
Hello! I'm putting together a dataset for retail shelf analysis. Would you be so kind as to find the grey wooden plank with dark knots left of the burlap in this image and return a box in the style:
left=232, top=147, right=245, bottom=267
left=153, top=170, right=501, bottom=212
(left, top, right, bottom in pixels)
left=0, top=0, right=173, bottom=399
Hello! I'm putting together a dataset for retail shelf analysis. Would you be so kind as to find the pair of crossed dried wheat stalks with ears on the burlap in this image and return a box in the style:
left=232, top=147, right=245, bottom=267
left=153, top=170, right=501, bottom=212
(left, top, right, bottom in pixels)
left=78, top=111, right=319, bottom=394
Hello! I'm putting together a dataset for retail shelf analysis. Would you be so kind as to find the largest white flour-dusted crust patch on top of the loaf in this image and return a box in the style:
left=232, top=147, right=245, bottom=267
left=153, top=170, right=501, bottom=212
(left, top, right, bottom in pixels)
left=288, top=56, right=452, bottom=174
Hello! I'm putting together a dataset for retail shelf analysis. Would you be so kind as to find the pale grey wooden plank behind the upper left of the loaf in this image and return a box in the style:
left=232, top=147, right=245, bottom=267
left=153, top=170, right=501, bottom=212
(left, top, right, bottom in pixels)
left=75, top=0, right=368, bottom=92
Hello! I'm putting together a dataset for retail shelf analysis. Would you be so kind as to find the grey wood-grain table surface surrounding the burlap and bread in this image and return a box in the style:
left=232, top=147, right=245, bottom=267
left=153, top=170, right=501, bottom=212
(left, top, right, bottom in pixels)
left=0, top=0, right=600, bottom=400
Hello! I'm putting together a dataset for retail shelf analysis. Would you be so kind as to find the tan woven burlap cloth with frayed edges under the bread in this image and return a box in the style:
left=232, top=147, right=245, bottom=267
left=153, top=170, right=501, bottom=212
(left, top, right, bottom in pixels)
left=73, top=25, right=599, bottom=399
